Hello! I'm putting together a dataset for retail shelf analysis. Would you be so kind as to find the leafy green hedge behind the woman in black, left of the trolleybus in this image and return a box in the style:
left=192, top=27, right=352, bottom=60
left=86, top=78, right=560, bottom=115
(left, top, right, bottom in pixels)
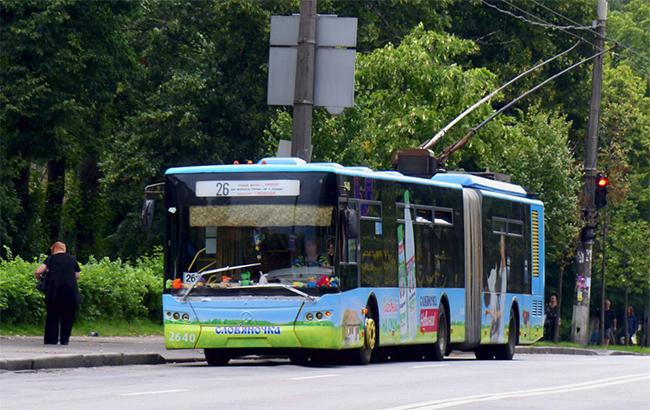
left=0, top=248, right=163, bottom=323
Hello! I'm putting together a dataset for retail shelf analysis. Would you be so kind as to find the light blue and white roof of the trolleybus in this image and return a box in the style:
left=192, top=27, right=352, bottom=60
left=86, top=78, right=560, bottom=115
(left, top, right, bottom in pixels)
left=165, top=158, right=543, bottom=206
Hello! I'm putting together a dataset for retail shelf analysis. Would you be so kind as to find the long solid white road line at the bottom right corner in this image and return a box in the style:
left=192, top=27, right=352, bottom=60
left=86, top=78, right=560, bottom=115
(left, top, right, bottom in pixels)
left=385, top=373, right=650, bottom=410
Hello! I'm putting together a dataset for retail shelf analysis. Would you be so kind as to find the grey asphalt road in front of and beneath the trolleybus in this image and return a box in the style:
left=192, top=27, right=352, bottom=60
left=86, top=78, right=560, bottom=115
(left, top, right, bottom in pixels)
left=0, top=354, right=650, bottom=410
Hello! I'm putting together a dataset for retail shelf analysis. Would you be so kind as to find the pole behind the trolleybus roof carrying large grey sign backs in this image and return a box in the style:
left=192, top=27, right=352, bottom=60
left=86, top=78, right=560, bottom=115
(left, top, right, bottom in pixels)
left=291, top=0, right=316, bottom=162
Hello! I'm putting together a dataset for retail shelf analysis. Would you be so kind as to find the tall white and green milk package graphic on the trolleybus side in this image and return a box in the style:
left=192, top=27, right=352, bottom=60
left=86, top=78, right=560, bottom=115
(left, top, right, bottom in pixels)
left=397, top=191, right=418, bottom=341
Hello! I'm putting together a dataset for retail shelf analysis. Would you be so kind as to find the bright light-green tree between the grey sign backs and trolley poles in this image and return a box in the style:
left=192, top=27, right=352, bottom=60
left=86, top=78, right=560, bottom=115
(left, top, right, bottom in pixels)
left=267, top=25, right=494, bottom=168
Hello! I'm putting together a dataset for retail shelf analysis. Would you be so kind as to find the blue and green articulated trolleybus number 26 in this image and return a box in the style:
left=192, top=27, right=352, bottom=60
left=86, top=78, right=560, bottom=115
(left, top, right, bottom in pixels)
left=158, top=158, right=544, bottom=365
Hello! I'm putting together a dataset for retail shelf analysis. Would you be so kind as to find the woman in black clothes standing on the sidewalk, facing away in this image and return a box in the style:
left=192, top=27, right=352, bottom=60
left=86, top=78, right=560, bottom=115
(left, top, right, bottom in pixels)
left=34, top=242, right=81, bottom=345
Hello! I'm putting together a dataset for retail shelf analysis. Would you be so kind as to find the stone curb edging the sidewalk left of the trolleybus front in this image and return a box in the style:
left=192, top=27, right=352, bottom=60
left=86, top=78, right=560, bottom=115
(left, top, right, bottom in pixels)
left=0, top=353, right=203, bottom=371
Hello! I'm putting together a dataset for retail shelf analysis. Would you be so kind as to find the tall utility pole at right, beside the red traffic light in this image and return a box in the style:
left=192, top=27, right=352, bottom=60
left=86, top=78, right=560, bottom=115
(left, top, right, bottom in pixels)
left=571, top=0, right=607, bottom=345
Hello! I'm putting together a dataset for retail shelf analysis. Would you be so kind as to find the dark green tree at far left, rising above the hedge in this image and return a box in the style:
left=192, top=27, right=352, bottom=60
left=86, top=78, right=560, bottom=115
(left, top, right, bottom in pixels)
left=0, top=0, right=137, bottom=254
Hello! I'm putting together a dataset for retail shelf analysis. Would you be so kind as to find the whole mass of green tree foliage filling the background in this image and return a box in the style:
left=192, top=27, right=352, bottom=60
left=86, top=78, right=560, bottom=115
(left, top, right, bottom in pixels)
left=0, top=0, right=650, bottom=316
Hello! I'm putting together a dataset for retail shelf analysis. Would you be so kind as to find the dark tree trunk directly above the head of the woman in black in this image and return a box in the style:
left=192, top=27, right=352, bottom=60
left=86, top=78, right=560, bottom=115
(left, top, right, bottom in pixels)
left=43, top=158, right=65, bottom=243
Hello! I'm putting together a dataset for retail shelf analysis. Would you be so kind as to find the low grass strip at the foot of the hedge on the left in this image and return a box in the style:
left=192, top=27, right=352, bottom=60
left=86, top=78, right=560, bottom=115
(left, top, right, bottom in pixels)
left=0, top=319, right=163, bottom=336
